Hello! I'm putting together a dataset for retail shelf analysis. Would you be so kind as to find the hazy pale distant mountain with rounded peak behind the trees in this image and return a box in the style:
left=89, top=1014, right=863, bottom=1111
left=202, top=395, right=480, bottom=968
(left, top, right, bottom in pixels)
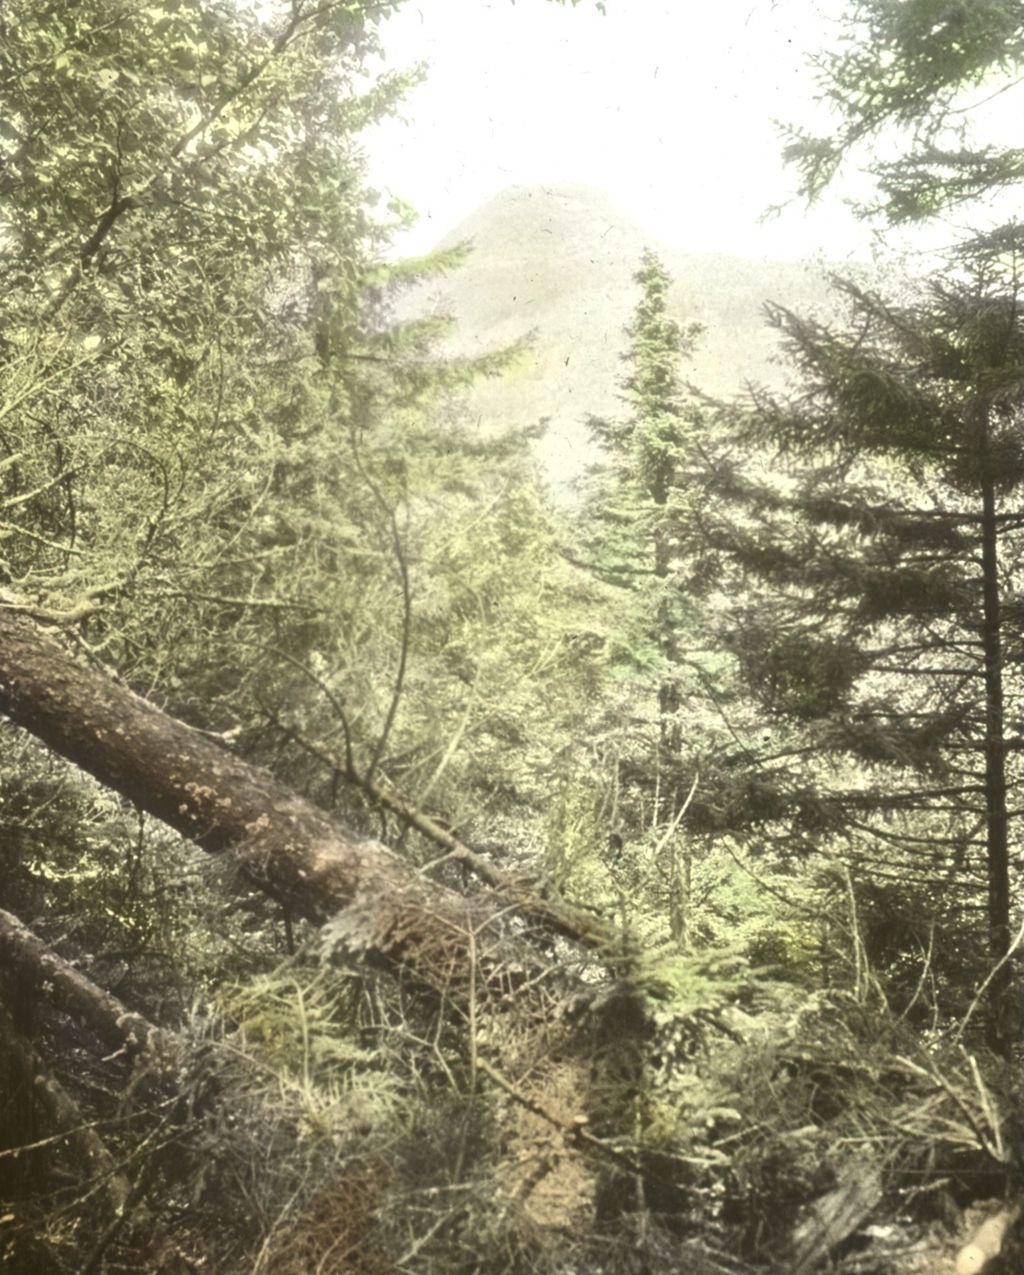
left=417, top=184, right=828, bottom=491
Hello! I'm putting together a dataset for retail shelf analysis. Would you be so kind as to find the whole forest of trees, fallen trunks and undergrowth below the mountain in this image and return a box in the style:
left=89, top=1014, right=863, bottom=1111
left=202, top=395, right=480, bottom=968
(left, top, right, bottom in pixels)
left=0, top=0, right=1024, bottom=1275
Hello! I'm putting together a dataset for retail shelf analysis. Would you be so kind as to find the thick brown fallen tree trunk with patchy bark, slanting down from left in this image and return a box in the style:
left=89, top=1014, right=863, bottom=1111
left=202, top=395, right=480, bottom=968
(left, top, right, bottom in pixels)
left=0, top=606, right=520, bottom=992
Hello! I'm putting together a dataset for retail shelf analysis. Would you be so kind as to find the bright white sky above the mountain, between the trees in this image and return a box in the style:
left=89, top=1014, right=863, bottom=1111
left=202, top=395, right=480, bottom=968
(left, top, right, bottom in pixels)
left=366, top=0, right=870, bottom=261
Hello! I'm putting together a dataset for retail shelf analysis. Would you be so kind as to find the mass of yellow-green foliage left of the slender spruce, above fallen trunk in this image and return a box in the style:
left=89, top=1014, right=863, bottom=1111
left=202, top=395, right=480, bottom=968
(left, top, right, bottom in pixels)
left=3, top=4, right=601, bottom=846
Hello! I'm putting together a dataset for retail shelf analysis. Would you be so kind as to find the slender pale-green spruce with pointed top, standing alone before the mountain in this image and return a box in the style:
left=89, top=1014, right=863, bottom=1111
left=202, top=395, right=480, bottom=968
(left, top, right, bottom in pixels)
left=585, top=250, right=724, bottom=945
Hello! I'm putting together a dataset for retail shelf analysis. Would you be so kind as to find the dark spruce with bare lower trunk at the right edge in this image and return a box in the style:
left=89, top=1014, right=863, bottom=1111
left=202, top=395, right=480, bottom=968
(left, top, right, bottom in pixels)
left=704, top=253, right=1024, bottom=1051
